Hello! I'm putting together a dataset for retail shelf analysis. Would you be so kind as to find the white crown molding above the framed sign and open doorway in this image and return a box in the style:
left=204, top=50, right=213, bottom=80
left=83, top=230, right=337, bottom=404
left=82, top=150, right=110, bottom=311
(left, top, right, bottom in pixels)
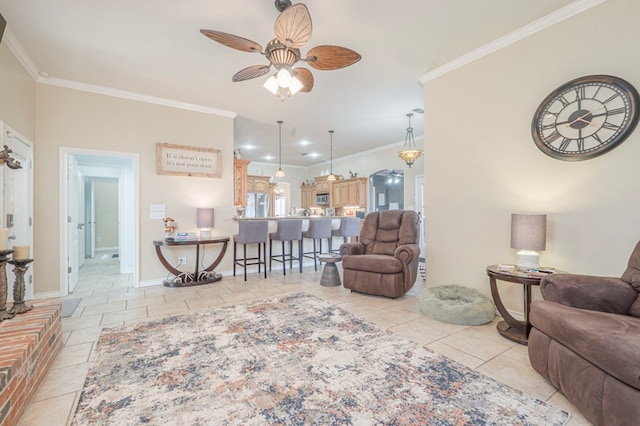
left=36, top=76, right=238, bottom=118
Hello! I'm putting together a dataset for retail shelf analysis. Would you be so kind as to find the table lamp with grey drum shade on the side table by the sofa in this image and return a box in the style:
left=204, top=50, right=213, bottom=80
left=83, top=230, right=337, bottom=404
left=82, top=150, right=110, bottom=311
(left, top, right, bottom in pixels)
left=511, top=214, right=547, bottom=269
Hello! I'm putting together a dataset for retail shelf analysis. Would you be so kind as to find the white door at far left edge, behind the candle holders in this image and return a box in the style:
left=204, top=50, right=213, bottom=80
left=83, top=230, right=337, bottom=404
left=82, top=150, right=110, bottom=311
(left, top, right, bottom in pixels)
left=0, top=127, right=34, bottom=300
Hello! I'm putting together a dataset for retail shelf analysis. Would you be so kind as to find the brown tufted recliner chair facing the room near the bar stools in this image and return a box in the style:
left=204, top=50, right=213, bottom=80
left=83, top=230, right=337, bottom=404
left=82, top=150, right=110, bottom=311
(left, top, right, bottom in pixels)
left=340, top=210, right=420, bottom=298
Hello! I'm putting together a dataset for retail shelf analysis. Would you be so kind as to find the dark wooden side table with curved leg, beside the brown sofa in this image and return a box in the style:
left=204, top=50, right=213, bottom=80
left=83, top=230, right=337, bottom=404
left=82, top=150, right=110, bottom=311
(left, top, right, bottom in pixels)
left=487, top=265, right=548, bottom=345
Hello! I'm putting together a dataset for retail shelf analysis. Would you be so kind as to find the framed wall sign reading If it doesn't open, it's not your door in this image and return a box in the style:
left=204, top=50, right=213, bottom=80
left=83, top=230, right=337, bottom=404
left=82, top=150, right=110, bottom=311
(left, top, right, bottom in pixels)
left=156, top=143, right=222, bottom=178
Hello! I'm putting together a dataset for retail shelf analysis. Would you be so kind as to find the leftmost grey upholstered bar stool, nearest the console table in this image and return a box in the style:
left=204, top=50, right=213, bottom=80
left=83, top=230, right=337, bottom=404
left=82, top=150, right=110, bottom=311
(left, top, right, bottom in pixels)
left=233, top=220, right=269, bottom=281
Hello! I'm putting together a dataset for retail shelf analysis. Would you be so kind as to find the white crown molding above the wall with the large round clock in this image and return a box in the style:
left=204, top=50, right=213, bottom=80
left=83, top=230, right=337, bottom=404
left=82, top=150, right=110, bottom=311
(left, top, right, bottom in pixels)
left=418, top=0, right=607, bottom=84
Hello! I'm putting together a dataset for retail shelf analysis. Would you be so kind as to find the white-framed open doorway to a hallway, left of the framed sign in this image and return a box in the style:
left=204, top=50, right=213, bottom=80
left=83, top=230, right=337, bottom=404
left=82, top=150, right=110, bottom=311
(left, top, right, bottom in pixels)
left=60, top=148, right=139, bottom=296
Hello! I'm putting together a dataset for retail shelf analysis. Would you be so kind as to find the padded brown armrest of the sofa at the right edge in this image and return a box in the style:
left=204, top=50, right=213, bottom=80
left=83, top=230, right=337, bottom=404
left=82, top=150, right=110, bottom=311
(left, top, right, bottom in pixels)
left=540, top=274, right=638, bottom=314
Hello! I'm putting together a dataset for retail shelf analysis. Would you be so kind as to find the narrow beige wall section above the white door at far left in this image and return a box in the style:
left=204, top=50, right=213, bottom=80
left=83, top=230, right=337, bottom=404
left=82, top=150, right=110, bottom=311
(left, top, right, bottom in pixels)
left=0, top=42, right=36, bottom=143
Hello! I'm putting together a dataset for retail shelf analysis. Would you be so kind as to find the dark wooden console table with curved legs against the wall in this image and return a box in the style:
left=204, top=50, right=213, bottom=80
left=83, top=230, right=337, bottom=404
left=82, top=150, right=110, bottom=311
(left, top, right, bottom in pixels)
left=153, top=237, right=229, bottom=287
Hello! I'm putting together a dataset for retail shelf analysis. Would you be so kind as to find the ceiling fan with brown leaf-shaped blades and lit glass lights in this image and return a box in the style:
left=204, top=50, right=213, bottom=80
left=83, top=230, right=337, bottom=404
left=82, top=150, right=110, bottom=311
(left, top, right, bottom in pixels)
left=200, top=0, right=361, bottom=100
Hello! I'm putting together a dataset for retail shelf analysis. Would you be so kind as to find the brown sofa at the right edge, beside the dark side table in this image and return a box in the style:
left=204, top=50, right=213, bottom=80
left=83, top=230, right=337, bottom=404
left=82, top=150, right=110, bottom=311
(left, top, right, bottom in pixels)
left=529, top=242, right=640, bottom=425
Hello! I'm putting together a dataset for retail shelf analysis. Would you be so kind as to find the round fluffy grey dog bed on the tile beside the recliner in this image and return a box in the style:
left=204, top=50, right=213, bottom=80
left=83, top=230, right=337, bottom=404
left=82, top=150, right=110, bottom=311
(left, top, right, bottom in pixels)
left=420, top=285, right=495, bottom=325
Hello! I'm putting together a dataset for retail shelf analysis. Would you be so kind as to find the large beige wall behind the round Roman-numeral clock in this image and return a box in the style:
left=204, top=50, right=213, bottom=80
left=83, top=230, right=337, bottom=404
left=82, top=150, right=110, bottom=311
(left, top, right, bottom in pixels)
left=424, top=0, right=640, bottom=311
